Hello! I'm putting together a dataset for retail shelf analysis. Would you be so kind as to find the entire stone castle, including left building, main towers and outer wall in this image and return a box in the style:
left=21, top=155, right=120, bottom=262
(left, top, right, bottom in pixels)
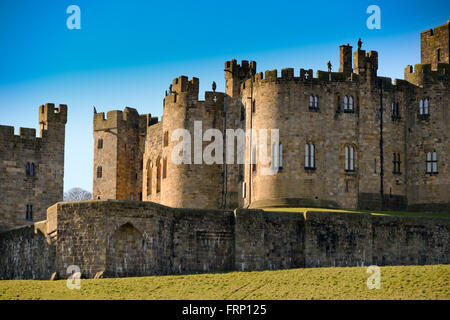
left=0, top=22, right=450, bottom=279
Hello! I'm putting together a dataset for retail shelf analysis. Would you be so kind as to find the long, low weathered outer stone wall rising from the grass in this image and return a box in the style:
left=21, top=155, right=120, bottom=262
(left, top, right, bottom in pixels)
left=0, top=200, right=450, bottom=279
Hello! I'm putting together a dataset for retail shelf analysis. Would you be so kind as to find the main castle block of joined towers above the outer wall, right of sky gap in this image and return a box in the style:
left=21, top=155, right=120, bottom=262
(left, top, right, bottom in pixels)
left=93, top=23, right=450, bottom=212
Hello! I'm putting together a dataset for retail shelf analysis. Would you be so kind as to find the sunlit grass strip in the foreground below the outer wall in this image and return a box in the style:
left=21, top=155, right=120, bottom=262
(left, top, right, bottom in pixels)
left=0, top=265, right=450, bottom=300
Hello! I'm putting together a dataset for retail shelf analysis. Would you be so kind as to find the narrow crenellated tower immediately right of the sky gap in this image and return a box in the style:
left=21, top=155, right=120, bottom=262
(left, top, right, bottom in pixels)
left=92, top=107, right=151, bottom=200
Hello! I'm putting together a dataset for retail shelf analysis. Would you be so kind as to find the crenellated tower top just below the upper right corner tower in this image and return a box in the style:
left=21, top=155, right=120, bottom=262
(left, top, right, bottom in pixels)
left=405, top=63, right=450, bottom=87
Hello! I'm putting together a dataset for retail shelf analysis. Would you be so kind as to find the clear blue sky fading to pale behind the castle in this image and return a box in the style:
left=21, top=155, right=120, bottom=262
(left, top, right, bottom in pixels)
left=0, top=0, right=450, bottom=191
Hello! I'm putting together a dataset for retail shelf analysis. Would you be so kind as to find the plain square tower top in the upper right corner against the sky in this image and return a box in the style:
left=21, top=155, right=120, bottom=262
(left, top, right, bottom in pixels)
left=420, top=21, right=450, bottom=70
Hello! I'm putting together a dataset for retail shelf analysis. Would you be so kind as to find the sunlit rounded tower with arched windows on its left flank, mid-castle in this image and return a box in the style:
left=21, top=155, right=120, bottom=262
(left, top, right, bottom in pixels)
left=143, top=76, right=224, bottom=208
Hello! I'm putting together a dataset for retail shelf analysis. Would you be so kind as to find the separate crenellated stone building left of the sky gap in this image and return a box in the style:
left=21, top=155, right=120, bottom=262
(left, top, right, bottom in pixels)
left=0, top=103, right=67, bottom=230
